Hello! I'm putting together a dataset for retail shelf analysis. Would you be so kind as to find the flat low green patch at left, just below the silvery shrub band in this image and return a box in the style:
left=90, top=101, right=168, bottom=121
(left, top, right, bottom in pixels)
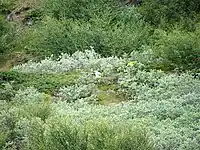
left=0, top=71, right=80, bottom=94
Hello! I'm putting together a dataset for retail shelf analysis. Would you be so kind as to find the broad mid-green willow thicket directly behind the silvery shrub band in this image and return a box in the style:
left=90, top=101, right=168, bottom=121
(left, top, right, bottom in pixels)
left=17, top=10, right=151, bottom=56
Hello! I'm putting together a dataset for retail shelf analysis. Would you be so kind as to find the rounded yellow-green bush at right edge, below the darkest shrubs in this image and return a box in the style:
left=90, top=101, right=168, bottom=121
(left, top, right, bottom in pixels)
left=153, top=29, right=200, bottom=70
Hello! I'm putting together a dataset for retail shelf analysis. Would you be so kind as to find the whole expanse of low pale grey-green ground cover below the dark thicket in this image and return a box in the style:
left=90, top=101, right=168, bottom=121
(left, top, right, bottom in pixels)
left=1, top=50, right=200, bottom=150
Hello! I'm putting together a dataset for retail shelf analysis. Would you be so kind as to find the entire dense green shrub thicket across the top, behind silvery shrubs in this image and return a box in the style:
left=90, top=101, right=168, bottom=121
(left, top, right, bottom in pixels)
left=10, top=0, right=200, bottom=70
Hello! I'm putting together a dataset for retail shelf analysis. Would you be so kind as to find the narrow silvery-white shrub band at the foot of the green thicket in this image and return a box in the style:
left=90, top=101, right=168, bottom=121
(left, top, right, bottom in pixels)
left=13, top=47, right=123, bottom=73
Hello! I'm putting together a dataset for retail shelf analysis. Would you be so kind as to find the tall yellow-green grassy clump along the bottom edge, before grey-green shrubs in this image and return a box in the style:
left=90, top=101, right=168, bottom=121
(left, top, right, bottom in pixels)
left=23, top=117, right=155, bottom=150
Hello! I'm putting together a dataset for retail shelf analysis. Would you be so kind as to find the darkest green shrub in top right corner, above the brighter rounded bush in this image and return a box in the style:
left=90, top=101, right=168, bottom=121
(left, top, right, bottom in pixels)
left=139, top=0, right=200, bottom=30
